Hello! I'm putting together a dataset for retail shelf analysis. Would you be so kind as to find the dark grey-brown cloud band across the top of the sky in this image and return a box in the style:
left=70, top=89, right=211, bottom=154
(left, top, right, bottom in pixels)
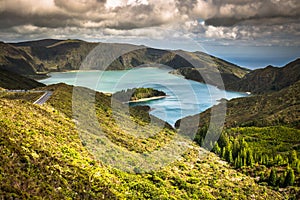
left=0, top=0, right=300, bottom=29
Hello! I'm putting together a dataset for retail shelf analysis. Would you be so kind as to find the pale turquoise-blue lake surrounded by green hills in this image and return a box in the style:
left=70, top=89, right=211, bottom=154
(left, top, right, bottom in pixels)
left=40, top=67, right=246, bottom=125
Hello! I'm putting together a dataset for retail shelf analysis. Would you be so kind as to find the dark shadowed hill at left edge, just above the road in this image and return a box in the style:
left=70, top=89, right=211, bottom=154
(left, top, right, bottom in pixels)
left=0, top=68, right=45, bottom=90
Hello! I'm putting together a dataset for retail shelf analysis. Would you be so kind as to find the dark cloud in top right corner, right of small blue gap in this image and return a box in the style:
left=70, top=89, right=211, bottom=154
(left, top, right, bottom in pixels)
left=205, top=0, right=300, bottom=26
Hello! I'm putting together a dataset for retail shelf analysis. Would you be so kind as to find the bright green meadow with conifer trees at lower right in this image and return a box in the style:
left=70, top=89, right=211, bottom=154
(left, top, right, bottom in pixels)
left=195, top=126, right=300, bottom=199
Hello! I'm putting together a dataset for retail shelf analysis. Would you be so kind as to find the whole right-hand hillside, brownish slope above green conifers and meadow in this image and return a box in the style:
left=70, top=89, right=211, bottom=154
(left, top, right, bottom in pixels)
left=176, top=81, right=300, bottom=199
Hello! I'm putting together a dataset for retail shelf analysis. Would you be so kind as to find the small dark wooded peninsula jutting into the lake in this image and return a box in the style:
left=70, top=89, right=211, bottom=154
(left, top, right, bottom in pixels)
left=113, top=88, right=166, bottom=102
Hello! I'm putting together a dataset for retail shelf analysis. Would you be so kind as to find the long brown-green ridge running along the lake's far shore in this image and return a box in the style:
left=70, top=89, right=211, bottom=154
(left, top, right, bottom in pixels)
left=0, top=39, right=249, bottom=80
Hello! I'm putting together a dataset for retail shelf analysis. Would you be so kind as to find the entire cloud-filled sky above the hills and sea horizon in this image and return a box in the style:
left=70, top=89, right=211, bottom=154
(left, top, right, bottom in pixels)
left=0, top=0, right=300, bottom=45
